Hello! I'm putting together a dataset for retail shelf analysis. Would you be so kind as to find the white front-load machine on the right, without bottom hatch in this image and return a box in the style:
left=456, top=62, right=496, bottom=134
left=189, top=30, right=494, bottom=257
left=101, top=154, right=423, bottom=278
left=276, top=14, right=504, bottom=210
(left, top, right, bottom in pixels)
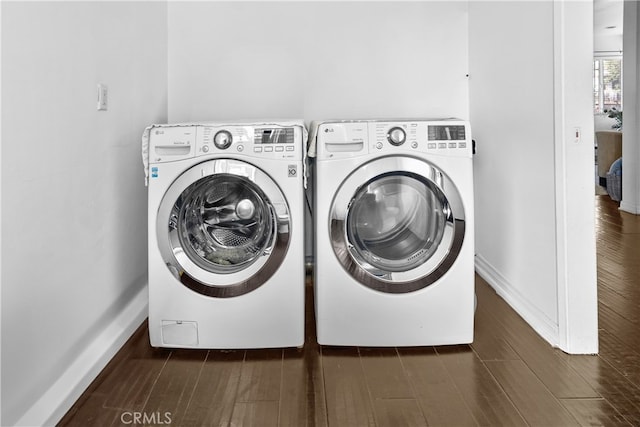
left=309, top=119, right=475, bottom=347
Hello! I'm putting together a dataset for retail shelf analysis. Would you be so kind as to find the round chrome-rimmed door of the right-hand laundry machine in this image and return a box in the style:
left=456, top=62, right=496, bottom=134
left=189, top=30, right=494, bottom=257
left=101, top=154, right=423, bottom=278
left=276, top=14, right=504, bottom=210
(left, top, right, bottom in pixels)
left=330, top=157, right=465, bottom=293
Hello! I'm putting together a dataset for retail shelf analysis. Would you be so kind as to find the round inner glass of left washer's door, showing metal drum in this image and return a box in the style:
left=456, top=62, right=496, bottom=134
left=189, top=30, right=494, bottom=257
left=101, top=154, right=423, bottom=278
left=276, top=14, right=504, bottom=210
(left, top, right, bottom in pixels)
left=175, top=174, right=275, bottom=274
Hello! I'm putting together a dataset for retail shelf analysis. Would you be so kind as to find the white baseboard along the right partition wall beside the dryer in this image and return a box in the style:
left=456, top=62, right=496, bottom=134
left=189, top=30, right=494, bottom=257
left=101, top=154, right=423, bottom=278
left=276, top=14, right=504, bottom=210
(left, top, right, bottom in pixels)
left=475, top=255, right=560, bottom=347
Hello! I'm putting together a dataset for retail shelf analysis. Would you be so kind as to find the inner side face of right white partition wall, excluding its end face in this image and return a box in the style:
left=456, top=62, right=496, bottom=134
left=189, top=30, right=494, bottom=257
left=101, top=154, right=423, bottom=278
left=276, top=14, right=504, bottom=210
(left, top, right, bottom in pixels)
left=469, top=1, right=559, bottom=343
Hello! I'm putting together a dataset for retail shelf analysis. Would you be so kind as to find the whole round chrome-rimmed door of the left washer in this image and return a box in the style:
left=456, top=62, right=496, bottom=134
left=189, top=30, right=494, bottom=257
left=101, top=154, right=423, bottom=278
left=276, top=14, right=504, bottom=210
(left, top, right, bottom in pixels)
left=156, top=159, right=290, bottom=297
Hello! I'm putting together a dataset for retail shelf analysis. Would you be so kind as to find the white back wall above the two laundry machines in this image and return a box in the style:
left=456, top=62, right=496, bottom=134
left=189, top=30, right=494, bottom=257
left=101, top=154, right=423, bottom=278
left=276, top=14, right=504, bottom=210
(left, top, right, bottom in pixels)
left=169, top=2, right=468, bottom=122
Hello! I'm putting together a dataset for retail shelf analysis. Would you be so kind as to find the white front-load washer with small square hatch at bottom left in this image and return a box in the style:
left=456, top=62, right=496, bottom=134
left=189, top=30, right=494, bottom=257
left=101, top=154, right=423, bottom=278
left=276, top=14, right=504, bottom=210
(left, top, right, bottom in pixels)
left=143, top=121, right=306, bottom=349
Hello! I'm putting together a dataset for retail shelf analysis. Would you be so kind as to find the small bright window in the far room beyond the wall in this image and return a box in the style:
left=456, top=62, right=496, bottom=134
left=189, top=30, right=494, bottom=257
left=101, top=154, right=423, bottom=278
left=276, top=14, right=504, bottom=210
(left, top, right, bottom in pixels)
left=593, top=57, right=622, bottom=114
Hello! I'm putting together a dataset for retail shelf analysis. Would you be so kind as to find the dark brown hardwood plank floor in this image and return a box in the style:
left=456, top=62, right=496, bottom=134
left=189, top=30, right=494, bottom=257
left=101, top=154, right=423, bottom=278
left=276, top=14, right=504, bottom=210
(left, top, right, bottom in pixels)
left=60, top=196, right=640, bottom=427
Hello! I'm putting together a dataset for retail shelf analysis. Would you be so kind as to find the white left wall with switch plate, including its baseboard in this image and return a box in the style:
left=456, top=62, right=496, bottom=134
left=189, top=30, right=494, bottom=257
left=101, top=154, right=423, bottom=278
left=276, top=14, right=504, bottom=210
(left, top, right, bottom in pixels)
left=1, top=2, right=167, bottom=425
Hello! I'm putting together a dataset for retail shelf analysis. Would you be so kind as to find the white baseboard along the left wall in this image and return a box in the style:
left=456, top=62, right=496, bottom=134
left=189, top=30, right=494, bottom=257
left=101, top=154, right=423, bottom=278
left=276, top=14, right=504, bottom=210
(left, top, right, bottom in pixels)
left=16, top=285, right=149, bottom=426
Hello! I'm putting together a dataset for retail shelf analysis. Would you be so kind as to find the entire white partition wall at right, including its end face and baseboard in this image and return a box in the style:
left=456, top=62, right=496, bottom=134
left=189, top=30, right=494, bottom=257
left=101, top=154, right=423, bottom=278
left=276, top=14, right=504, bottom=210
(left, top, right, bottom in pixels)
left=469, top=1, right=597, bottom=353
